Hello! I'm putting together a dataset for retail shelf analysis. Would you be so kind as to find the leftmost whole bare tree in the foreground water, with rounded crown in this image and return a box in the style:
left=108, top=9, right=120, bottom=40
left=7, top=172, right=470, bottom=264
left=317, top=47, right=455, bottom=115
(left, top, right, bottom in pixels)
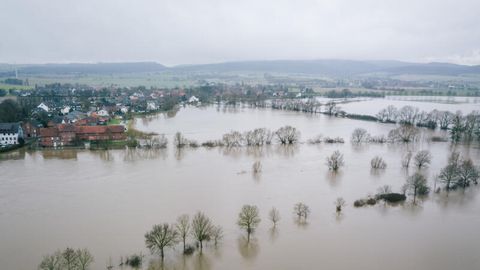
left=145, top=223, right=178, bottom=260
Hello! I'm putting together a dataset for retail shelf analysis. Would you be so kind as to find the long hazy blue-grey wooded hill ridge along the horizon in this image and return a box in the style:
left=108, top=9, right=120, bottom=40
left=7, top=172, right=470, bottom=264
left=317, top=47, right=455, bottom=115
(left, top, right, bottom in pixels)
left=0, top=60, right=480, bottom=77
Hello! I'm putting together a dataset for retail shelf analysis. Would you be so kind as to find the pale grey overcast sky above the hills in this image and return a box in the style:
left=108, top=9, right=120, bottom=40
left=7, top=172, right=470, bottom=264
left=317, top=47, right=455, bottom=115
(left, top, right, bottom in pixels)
left=0, top=0, right=480, bottom=65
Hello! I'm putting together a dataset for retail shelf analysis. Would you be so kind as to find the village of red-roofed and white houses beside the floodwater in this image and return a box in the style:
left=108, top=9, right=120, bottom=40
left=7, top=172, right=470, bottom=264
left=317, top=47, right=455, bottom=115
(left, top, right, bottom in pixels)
left=0, top=84, right=201, bottom=152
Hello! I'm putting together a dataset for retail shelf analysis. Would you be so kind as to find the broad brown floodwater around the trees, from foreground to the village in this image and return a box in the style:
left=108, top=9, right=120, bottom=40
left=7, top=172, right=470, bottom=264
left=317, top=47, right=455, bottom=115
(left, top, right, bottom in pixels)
left=0, top=103, right=480, bottom=270
